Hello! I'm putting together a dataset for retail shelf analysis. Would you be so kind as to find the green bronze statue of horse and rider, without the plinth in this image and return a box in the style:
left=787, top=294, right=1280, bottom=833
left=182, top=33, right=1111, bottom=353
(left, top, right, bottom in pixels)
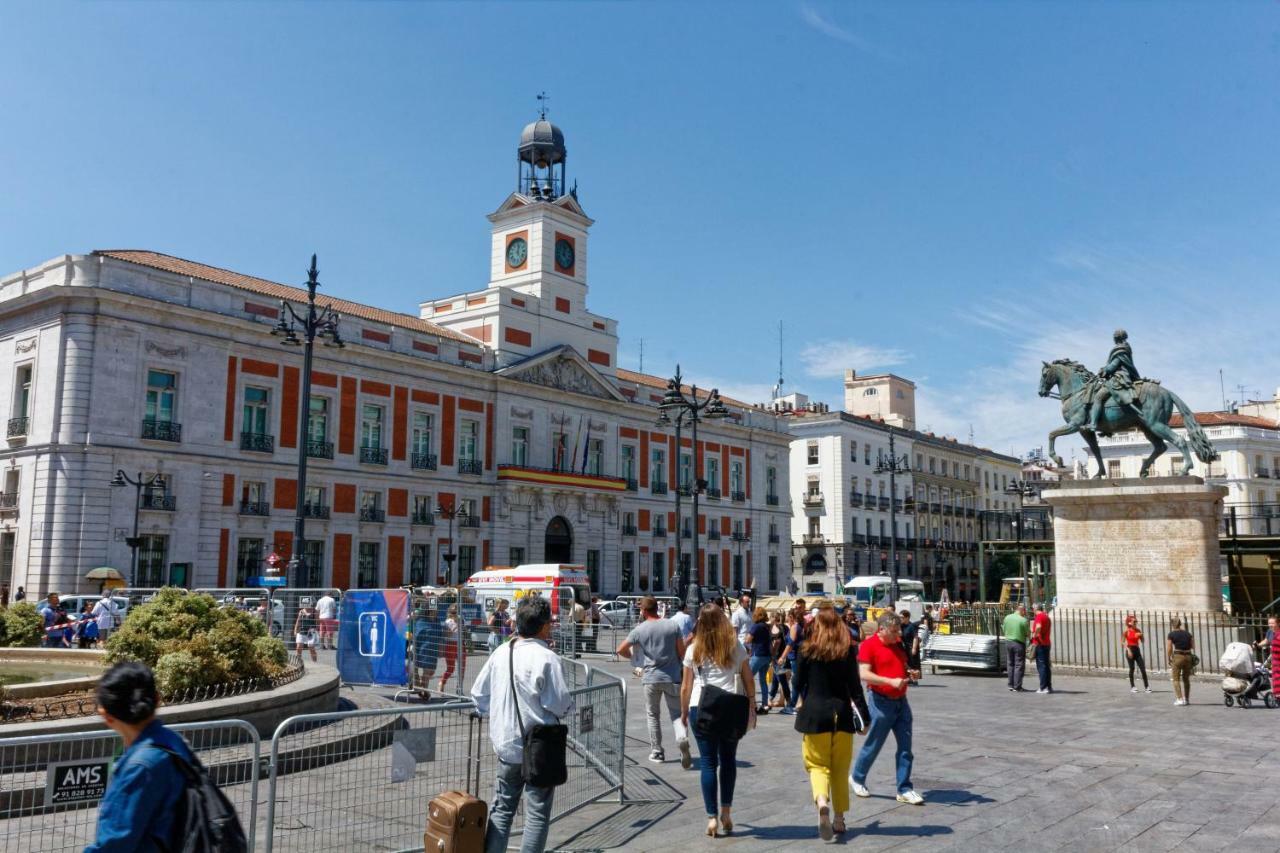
left=1039, top=329, right=1217, bottom=479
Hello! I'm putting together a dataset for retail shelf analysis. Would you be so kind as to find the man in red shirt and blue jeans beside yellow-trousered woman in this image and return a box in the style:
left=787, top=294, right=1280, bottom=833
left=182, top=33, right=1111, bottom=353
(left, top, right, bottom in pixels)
left=852, top=610, right=924, bottom=806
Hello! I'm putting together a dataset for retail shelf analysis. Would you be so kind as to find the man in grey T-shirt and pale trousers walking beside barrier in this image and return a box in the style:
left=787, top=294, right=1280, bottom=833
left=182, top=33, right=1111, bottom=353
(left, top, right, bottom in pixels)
left=618, top=596, right=694, bottom=770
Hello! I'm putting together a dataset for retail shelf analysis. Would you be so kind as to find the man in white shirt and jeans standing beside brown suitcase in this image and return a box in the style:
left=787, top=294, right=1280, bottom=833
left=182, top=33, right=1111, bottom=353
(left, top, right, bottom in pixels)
left=471, top=596, right=575, bottom=853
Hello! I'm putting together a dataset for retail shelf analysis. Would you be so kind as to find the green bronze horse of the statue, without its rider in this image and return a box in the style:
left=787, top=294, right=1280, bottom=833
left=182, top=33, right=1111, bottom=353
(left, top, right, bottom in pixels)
left=1039, top=359, right=1217, bottom=479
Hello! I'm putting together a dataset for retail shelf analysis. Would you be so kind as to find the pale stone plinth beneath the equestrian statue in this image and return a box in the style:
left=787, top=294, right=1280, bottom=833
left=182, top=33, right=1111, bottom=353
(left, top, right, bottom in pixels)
left=1044, top=476, right=1226, bottom=612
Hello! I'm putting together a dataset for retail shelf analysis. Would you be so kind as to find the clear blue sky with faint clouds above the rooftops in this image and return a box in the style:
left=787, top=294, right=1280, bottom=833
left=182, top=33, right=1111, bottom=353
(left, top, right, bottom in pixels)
left=0, top=0, right=1280, bottom=452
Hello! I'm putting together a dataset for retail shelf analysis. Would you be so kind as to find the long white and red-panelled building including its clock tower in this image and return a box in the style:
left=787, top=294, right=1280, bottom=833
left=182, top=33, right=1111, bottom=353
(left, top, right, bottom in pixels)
left=0, top=120, right=790, bottom=596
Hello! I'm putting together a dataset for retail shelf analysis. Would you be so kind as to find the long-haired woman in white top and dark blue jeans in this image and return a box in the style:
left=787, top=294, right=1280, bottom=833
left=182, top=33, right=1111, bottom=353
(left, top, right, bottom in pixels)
left=680, top=605, right=755, bottom=838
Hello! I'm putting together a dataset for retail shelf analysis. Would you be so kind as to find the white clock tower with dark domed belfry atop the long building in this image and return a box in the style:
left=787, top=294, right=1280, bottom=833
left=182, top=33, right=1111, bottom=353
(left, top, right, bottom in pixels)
left=421, top=110, right=618, bottom=377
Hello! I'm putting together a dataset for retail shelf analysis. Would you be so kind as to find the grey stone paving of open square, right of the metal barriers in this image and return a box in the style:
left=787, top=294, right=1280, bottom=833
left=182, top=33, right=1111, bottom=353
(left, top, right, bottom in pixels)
left=540, top=658, right=1280, bottom=853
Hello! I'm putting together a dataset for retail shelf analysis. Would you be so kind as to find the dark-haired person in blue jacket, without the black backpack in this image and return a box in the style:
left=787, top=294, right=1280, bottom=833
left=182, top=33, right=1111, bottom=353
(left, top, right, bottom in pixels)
left=84, top=661, right=193, bottom=853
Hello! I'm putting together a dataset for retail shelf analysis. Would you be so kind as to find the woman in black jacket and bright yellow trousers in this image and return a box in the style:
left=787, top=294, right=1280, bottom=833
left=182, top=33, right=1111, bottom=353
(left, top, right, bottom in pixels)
left=794, top=606, right=870, bottom=841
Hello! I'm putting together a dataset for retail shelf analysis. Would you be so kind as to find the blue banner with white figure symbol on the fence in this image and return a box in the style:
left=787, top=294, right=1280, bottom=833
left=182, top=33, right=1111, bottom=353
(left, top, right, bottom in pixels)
left=338, top=589, right=408, bottom=686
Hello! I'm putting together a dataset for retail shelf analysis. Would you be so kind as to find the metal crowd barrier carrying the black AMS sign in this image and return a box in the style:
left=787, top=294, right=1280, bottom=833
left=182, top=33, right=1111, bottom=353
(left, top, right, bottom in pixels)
left=0, top=720, right=261, bottom=853
